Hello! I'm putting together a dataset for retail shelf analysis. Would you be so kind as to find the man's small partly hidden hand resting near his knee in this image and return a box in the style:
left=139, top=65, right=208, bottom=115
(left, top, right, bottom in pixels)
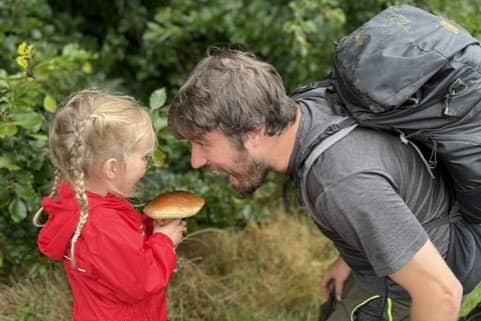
left=322, top=257, right=351, bottom=301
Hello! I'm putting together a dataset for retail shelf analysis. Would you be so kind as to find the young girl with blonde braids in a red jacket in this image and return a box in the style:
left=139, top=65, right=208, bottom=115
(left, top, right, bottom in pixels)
left=34, top=90, right=186, bottom=321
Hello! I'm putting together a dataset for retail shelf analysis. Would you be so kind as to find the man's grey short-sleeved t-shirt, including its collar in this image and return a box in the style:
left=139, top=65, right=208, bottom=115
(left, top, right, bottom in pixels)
left=289, top=87, right=480, bottom=298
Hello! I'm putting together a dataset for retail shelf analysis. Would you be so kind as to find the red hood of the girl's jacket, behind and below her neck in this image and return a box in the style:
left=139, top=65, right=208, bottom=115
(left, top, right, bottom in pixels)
left=38, top=183, right=132, bottom=261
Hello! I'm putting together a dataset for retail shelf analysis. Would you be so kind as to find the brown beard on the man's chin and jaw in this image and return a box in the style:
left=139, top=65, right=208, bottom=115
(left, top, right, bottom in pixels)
left=230, top=156, right=269, bottom=197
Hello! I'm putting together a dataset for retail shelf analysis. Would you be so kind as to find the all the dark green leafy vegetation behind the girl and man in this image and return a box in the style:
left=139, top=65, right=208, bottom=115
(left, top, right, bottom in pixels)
left=0, top=0, right=481, bottom=280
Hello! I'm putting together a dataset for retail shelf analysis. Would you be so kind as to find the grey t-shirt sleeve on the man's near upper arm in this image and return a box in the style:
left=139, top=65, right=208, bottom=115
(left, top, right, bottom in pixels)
left=315, top=170, right=428, bottom=277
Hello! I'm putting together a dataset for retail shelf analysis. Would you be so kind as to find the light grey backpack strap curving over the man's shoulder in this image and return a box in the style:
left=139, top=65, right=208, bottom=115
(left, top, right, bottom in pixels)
left=300, top=117, right=358, bottom=214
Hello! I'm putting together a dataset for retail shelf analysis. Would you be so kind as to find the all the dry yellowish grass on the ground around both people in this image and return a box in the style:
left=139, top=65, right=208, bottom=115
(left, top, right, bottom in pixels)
left=0, top=209, right=481, bottom=321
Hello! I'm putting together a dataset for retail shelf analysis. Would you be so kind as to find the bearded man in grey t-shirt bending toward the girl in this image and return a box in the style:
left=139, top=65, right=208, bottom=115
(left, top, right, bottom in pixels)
left=169, top=51, right=481, bottom=321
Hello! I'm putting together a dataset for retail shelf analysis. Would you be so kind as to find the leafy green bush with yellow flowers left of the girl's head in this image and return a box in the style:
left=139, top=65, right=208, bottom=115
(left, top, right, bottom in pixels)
left=0, top=36, right=95, bottom=272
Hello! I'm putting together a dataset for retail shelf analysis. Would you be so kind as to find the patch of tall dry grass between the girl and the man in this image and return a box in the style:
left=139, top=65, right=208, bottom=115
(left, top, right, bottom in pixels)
left=169, top=210, right=336, bottom=321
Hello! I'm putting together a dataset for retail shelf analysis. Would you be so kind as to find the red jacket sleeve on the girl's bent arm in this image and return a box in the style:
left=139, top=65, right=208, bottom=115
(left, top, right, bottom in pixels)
left=84, top=211, right=177, bottom=303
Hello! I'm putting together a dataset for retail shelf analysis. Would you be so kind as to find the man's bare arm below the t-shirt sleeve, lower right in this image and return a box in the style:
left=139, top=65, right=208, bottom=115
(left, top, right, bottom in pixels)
left=390, top=240, right=463, bottom=321
